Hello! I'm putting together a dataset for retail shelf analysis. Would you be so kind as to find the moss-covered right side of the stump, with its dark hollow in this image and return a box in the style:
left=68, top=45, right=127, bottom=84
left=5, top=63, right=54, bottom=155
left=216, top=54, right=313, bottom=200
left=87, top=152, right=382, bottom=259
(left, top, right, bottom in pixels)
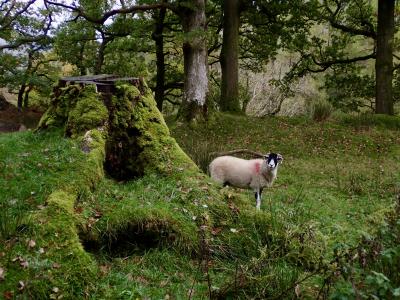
left=107, top=85, right=199, bottom=179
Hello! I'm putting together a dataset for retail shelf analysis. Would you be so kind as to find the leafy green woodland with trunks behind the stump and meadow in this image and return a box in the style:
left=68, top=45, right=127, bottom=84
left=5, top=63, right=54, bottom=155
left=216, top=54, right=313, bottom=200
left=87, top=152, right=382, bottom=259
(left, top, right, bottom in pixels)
left=0, top=0, right=399, bottom=115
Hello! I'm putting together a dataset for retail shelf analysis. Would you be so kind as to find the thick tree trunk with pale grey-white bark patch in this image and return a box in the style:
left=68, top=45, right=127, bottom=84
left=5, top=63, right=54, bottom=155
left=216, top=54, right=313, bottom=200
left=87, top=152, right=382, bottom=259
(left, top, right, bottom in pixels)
left=179, top=0, right=208, bottom=122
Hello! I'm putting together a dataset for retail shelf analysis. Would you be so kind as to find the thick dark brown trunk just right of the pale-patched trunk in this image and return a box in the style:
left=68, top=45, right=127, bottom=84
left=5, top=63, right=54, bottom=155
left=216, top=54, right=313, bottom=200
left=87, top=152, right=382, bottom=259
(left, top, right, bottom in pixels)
left=220, top=0, right=240, bottom=111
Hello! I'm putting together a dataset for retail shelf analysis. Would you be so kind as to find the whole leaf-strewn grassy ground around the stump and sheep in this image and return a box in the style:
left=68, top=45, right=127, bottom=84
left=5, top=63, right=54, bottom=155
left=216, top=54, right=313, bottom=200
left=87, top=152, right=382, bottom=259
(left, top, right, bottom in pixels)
left=0, top=115, right=400, bottom=299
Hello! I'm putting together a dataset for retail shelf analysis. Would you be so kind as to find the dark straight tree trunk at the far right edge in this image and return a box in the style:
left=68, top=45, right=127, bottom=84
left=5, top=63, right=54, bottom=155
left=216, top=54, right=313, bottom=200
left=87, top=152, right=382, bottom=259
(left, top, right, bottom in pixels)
left=375, top=0, right=395, bottom=115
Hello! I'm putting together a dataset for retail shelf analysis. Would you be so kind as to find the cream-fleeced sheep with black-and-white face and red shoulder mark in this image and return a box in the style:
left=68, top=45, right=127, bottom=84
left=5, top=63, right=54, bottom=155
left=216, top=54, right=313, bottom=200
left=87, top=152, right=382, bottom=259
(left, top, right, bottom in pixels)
left=209, top=153, right=283, bottom=210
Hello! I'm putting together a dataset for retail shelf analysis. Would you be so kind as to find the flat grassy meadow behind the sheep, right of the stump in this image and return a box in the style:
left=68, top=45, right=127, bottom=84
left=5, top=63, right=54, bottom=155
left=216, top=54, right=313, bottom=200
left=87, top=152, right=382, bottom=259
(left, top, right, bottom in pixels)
left=172, top=116, right=400, bottom=246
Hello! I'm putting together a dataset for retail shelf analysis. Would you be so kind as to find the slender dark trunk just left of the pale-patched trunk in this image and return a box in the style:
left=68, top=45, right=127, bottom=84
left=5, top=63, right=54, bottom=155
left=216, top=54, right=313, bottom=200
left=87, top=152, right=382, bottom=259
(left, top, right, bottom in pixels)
left=152, top=7, right=166, bottom=111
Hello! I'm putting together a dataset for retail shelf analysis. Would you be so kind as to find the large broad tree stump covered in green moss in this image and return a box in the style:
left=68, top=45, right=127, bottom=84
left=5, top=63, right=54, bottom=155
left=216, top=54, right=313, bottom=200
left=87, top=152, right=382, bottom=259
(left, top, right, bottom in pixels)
left=38, top=75, right=198, bottom=180
